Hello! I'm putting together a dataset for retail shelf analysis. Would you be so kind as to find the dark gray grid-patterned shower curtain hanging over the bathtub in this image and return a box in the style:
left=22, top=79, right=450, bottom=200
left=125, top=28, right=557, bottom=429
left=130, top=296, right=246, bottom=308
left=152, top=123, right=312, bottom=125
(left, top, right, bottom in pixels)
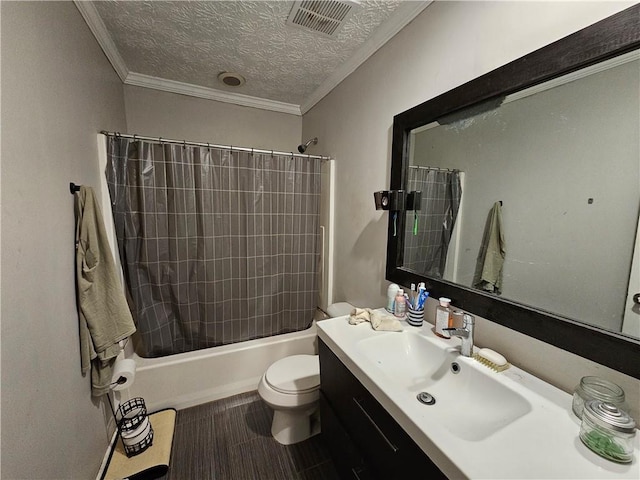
left=106, top=136, right=320, bottom=357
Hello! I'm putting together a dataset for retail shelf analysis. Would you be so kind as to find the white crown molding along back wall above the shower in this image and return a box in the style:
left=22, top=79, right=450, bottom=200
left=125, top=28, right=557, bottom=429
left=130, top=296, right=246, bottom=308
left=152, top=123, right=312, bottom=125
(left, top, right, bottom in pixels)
left=124, top=72, right=301, bottom=116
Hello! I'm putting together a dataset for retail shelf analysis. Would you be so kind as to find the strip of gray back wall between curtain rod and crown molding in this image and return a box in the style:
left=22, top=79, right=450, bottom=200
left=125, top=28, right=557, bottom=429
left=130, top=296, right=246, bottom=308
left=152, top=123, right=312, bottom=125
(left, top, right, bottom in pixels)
left=124, top=85, right=302, bottom=152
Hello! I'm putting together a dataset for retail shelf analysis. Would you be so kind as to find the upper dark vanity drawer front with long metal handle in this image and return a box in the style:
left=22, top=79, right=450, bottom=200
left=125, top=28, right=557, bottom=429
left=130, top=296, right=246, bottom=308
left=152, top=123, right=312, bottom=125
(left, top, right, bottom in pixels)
left=319, top=340, right=445, bottom=480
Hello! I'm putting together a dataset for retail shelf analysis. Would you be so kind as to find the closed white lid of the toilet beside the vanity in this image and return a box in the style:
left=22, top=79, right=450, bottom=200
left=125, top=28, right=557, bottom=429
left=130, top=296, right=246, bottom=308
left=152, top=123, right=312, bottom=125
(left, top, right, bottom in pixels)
left=265, top=355, right=320, bottom=393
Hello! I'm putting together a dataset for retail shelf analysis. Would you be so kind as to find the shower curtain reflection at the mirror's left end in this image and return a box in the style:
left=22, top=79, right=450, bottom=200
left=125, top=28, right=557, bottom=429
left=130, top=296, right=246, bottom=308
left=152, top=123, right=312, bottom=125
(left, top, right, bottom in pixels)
left=403, top=167, right=462, bottom=278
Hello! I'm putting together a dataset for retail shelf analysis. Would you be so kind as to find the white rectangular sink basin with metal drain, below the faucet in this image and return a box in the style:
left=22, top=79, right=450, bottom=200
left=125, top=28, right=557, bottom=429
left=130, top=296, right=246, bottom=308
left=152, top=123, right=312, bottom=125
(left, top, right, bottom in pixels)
left=357, top=331, right=532, bottom=441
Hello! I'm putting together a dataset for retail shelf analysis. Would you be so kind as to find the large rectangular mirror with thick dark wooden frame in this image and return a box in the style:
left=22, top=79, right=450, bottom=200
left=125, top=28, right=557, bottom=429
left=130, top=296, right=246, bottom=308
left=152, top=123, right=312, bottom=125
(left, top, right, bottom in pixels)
left=387, top=6, right=640, bottom=378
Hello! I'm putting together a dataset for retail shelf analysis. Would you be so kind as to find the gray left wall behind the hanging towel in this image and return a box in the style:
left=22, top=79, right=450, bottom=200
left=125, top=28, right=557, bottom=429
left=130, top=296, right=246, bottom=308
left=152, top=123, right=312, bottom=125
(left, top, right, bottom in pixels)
left=0, top=2, right=126, bottom=479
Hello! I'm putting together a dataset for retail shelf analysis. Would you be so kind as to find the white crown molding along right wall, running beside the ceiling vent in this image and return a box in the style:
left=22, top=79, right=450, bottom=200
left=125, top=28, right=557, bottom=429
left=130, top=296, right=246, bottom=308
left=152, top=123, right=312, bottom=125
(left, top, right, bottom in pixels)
left=300, top=0, right=433, bottom=115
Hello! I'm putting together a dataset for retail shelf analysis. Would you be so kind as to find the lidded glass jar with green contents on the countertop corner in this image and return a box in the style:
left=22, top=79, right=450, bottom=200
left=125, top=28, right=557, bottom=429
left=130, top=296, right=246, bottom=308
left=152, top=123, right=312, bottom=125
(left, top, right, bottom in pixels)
left=580, top=400, right=636, bottom=463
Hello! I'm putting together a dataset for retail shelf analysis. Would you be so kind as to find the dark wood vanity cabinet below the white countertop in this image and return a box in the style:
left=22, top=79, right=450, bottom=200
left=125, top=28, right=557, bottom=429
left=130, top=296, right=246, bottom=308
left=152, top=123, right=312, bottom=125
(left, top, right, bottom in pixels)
left=318, top=340, right=446, bottom=480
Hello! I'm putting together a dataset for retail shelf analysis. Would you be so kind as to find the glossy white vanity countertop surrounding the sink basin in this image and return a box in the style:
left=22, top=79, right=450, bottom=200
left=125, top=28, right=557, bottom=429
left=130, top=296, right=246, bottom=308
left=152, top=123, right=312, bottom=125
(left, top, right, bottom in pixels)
left=317, top=316, right=640, bottom=480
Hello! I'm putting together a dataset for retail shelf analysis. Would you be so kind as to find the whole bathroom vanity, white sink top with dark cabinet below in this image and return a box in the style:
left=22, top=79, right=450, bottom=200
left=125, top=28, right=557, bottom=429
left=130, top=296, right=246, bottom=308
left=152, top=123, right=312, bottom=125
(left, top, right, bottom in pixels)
left=318, top=316, right=640, bottom=479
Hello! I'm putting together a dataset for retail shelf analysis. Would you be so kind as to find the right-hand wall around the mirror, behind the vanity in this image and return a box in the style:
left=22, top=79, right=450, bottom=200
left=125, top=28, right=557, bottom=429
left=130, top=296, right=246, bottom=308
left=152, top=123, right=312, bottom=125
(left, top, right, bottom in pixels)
left=303, top=2, right=640, bottom=418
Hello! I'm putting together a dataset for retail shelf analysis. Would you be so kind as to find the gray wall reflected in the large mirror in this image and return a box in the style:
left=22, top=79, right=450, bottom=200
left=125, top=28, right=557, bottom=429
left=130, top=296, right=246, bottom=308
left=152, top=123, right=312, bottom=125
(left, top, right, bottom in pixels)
left=412, top=60, right=640, bottom=332
